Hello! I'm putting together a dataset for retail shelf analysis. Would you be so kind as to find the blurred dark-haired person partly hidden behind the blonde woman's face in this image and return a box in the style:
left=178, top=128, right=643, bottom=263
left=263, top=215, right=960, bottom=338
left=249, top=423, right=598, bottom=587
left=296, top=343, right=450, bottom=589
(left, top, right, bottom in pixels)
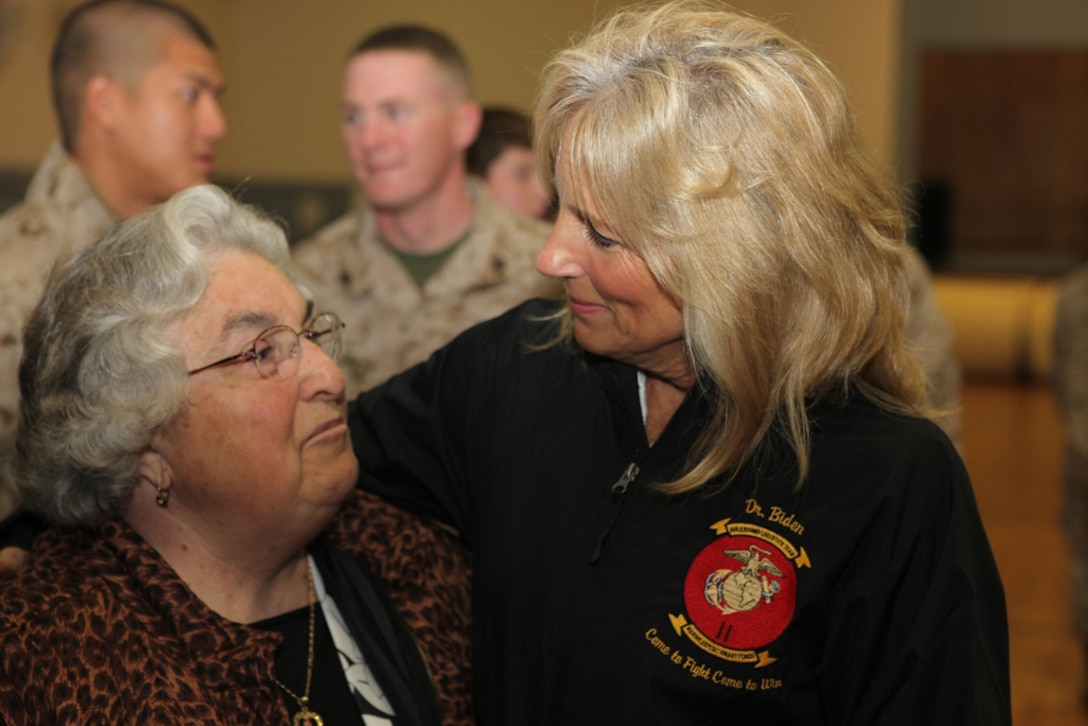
left=467, top=107, right=555, bottom=221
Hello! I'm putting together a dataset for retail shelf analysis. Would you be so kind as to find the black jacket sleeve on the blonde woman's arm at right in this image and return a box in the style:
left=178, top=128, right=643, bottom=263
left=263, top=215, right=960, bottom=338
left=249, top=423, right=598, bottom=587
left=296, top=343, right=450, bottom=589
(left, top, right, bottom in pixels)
left=823, top=444, right=1012, bottom=726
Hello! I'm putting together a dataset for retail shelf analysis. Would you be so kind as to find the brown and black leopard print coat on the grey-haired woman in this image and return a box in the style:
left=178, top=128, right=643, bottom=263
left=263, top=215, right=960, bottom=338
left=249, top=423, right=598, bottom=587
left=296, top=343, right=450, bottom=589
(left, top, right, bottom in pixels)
left=0, top=491, right=473, bottom=725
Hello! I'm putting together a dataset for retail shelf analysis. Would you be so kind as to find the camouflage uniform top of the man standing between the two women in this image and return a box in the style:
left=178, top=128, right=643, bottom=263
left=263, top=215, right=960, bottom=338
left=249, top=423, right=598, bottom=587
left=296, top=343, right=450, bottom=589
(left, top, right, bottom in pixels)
left=294, top=181, right=560, bottom=396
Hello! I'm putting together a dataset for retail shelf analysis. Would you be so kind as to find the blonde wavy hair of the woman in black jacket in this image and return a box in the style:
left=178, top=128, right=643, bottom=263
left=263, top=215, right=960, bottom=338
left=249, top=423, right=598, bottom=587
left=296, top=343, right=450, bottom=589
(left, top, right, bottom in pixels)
left=534, top=0, right=925, bottom=493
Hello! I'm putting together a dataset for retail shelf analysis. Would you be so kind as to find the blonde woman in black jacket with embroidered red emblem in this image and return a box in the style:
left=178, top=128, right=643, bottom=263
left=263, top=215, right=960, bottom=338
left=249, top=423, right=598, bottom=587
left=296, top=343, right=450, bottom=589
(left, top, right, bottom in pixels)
left=349, top=2, right=1010, bottom=726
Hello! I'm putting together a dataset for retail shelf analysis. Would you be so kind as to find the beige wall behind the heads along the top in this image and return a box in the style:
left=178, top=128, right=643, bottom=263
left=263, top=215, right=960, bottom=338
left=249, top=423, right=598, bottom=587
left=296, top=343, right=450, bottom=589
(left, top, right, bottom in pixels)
left=0, top=0, right=900, bottom=181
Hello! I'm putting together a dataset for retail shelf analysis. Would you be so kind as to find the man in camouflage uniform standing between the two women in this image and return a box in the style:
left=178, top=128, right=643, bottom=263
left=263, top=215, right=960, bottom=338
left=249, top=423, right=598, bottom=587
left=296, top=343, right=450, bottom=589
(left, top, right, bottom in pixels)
left=295, top=25, right=558, bottom=393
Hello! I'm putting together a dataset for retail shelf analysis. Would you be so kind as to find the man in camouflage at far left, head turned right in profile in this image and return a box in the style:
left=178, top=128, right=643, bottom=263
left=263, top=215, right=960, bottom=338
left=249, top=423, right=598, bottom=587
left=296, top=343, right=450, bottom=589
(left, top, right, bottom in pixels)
left=0, top=0, right=226, bottom=522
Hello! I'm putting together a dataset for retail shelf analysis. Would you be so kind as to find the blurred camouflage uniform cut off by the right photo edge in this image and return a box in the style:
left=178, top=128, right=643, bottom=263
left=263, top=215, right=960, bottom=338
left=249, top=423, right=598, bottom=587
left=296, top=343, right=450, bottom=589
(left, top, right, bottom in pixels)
left=1053, top=267, right=1088, bottom=644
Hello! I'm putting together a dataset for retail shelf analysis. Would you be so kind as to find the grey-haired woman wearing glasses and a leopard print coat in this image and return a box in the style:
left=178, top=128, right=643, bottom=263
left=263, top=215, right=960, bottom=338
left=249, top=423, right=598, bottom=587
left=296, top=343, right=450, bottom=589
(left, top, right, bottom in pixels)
left=0, top=186, right=471, bottom=726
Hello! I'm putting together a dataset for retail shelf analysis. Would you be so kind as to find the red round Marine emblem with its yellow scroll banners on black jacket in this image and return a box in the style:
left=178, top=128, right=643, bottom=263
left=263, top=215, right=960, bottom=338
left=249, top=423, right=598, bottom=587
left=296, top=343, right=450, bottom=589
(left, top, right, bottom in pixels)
left=669, top=519, right=811, bottom=668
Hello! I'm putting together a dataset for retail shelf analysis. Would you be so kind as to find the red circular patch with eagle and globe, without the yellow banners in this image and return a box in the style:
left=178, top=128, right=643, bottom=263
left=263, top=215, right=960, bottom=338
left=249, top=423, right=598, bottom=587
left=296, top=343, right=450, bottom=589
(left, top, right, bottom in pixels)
left=684, top=536, right=798, bottom=650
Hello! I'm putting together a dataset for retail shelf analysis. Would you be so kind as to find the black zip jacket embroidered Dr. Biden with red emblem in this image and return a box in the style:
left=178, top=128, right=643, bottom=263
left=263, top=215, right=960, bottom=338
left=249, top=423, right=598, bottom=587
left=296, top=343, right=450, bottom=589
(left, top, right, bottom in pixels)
left=349, top=302, right=1011, bottom=726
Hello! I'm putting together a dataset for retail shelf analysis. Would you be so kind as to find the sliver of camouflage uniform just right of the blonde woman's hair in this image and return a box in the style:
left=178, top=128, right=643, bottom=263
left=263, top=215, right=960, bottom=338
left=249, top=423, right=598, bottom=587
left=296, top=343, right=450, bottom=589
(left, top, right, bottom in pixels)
left=904, top=247, right=963, bottom=451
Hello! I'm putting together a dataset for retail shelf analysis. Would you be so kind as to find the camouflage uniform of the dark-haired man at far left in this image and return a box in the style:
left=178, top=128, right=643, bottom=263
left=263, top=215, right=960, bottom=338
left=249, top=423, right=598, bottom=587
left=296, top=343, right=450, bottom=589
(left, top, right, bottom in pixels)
left=0, top=144, right=116, bottom=516
